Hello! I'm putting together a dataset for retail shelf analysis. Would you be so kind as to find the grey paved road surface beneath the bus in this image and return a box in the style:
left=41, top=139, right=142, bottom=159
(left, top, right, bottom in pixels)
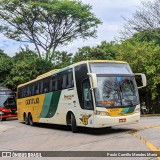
left=0, top=116, right=160, bottom=160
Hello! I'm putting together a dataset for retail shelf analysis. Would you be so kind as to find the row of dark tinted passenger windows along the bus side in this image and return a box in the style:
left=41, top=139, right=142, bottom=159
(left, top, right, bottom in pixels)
left=18, top=69, right=74, bottom=98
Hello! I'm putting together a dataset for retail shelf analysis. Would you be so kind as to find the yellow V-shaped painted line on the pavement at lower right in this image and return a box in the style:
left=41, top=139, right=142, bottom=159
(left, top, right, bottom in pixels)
left=127, top=126, right=160, bottom=160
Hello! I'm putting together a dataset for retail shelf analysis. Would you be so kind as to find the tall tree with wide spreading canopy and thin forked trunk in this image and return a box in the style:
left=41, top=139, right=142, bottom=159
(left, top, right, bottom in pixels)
left=0, top=0, right=101, bottom=61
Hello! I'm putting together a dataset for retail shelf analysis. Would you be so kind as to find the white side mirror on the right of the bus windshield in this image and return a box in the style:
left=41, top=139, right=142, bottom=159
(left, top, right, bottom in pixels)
left=134, top=73, right=147, bottom=89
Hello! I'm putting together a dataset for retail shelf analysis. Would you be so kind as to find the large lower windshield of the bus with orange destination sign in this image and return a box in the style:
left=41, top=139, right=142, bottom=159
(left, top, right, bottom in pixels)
left=95, top=75, right=139, bottom=108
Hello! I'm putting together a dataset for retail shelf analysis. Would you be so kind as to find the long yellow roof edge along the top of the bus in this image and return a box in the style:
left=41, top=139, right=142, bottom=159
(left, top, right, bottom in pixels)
left=18, top=60, right=127, bottom=87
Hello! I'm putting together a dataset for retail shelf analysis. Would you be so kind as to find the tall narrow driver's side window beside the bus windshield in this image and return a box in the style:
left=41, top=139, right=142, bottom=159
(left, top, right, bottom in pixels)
left=82, top=78, right=93, bottom=110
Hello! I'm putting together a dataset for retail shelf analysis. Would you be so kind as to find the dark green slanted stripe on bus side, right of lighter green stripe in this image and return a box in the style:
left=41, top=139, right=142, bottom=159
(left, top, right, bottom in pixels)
left=45, top=91, right=61, bottom=118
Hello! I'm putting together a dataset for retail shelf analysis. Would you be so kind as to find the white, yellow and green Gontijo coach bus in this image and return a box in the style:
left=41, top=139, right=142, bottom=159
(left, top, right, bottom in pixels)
left=17, top=60, right=146, bottom=132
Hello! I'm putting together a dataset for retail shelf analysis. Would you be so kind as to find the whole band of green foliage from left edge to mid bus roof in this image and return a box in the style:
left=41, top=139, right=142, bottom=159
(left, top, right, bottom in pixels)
left=0, top=47, right=72, bottom=90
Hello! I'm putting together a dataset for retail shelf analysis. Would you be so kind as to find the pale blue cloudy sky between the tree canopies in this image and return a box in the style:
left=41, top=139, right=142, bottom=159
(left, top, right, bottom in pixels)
left=0, top=0, right=144, bottom=57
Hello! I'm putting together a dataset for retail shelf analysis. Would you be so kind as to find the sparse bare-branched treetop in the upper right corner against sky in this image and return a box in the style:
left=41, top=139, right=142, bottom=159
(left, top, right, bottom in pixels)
left=121, top=0, right=160, bottom=40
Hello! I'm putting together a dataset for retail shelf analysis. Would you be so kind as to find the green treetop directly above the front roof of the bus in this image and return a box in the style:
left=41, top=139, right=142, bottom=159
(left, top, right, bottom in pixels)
left=73, top=41, right=117, bottom=62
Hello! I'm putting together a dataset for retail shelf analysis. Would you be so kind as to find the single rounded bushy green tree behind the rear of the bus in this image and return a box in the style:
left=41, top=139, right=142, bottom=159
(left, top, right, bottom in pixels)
left=5, top=48, right=54, bottom=90
